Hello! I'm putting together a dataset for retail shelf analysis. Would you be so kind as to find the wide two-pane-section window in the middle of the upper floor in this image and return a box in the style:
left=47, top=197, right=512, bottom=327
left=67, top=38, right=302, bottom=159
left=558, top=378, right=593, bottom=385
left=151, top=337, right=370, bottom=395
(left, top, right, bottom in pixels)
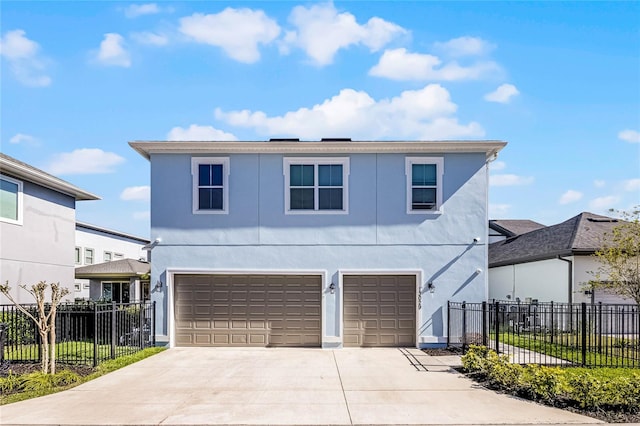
left=283, top=157, right=349, bottom=214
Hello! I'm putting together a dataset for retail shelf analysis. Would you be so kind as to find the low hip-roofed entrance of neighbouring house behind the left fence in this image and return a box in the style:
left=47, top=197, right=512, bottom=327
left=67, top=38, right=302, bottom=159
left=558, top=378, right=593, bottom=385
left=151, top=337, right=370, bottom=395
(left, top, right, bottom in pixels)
left=76, top=259, right=150, bottom=303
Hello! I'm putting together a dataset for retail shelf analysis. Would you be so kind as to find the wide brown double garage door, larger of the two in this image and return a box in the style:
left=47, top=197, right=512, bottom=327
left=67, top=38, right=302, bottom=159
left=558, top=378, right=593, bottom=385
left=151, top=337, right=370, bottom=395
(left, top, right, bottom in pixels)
left=175, top=275, right=321, bottom=346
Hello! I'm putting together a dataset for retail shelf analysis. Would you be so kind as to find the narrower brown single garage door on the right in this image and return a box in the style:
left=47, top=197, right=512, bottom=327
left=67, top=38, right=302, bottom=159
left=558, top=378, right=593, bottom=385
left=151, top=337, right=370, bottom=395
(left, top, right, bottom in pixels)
left=342, top=275, right=416, bottom=346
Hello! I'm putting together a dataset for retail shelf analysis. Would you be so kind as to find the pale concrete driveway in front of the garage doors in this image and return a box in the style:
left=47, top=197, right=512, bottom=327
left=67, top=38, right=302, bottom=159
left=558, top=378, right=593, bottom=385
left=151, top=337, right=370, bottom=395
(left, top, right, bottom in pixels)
left=0, top=348, right=600, bottom=425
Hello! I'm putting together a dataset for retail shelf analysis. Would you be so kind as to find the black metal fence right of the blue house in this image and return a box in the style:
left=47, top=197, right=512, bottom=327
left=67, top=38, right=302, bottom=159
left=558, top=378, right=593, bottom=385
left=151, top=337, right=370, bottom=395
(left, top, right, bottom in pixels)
left=447, top=301, right=640, bottom=367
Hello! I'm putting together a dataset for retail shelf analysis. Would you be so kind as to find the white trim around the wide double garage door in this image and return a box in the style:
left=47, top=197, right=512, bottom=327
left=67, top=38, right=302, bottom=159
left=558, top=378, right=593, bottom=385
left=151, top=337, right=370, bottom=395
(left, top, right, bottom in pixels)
left=165, top=268, right=328, bottom=348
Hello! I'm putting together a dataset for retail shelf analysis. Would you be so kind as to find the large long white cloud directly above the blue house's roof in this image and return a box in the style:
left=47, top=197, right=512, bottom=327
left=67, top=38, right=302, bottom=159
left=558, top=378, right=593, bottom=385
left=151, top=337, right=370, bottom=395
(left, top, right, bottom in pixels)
left=215, top=84, right=484, bottom=139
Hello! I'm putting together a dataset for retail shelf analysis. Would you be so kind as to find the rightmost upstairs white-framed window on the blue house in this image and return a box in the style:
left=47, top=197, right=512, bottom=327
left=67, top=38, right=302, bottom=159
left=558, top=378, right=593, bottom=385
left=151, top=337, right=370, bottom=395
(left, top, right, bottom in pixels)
left=405, top=157, right=444, bottom=214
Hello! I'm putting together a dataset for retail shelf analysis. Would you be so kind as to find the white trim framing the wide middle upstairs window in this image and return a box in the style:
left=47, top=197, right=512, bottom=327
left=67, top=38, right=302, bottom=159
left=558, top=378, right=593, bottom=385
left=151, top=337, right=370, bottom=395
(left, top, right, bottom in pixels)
left=282, top=157, right=350, bottom=215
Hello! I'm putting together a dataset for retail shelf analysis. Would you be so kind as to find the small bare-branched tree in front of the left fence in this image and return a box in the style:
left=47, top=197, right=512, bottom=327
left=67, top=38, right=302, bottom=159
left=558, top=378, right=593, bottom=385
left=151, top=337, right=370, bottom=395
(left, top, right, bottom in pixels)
left=0, top=281, right=69, bottom=374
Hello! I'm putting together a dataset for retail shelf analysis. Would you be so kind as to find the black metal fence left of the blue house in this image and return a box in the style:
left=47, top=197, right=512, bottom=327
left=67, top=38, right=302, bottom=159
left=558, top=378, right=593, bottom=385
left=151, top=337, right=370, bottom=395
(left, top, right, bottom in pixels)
left=0, top=302, right=155, bottom=367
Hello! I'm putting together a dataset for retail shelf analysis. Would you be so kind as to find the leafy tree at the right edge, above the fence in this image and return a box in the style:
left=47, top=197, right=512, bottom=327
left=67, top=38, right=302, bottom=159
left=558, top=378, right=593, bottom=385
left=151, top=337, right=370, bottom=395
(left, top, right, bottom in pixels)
left=591, top=206, right=640, bottom=304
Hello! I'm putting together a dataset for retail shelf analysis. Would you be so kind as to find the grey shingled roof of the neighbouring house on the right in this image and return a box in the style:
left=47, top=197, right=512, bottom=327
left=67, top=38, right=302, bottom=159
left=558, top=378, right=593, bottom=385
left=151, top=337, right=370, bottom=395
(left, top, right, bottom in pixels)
left=489, top=212, right=620, bottom=267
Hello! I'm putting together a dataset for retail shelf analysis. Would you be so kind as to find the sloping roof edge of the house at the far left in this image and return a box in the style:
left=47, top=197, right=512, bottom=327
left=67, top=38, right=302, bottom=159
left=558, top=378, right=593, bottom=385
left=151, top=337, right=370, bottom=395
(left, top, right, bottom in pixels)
left=0, top=152, right=100, bottom=201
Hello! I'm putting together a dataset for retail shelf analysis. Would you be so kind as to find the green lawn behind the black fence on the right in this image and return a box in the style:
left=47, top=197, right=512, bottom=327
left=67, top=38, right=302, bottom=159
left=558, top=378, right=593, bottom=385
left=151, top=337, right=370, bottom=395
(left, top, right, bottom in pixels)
left=491, top=333, right=640, bottom=367
